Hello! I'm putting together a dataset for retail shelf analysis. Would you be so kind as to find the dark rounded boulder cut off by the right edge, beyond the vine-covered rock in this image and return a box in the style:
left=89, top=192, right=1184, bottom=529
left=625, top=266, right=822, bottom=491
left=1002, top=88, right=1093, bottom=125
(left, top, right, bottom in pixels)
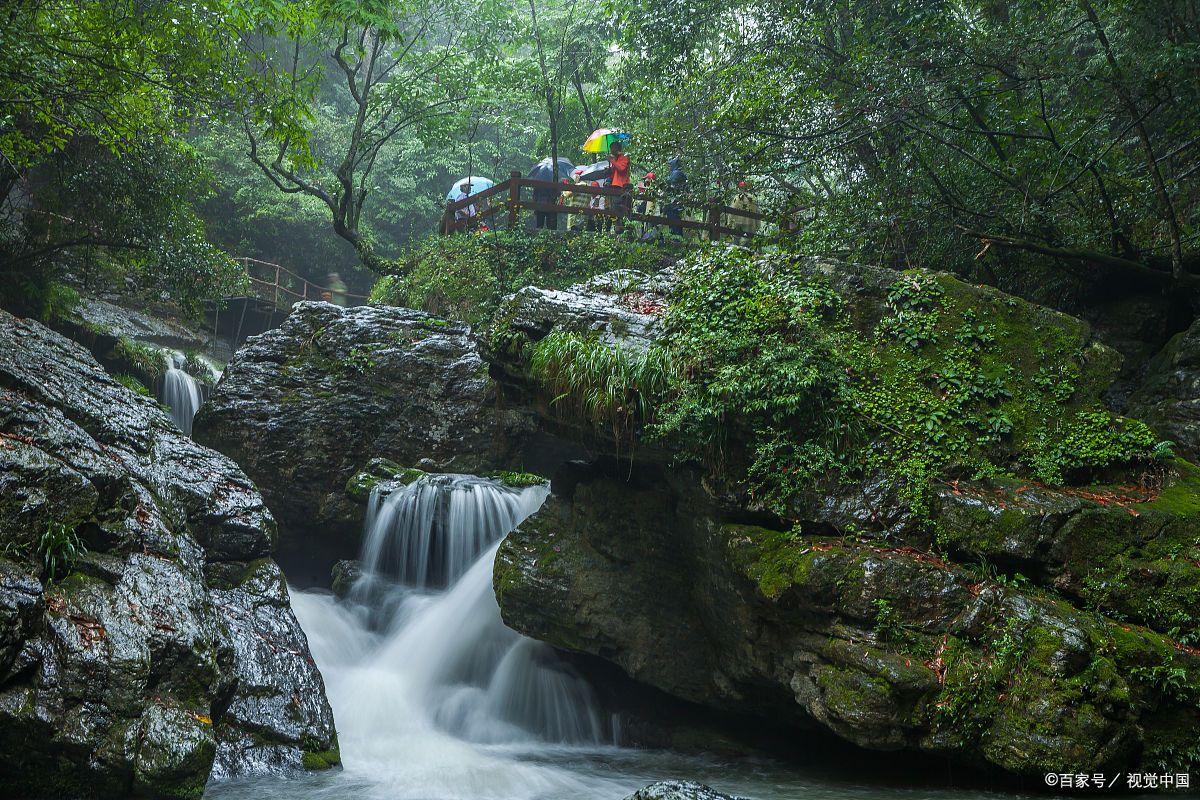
left=1129, top=321, right=1200, bottom=462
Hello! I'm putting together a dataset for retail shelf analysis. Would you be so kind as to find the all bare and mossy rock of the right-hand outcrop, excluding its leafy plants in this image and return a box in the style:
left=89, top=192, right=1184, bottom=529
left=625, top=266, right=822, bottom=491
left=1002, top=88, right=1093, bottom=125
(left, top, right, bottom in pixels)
left=486, top=259, right=1200, bottom=775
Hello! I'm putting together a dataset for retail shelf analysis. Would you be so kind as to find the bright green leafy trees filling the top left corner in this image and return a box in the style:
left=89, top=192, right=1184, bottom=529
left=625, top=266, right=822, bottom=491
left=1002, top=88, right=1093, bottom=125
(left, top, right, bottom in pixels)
left=0, top=0, right=267, bottom=318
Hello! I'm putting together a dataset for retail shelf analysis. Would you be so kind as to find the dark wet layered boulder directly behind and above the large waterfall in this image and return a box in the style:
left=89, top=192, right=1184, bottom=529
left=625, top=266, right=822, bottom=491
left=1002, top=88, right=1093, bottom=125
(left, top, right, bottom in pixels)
left=193, top=302, right=526, bottom=568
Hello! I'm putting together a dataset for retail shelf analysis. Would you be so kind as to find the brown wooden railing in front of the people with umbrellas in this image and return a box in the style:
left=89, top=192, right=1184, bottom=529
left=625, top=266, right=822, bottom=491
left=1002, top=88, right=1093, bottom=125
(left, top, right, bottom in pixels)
left=440, top=172, right=766, bottom=241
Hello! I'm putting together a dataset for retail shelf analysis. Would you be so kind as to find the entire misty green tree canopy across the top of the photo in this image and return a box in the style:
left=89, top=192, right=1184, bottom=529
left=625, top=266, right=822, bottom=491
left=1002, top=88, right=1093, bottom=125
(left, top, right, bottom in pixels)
left=0, top=0, right=1200, bottom=316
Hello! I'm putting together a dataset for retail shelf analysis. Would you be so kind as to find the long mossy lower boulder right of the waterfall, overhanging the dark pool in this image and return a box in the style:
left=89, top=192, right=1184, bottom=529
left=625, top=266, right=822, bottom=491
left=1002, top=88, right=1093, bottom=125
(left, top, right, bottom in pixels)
left=494, top=475, right=1200, bottom=775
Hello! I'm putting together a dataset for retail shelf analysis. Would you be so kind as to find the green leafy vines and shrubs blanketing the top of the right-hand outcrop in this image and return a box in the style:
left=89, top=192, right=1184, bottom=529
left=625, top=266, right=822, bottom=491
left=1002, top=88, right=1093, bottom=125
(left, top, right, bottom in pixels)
left=654, top=248, right=1156, bottom=516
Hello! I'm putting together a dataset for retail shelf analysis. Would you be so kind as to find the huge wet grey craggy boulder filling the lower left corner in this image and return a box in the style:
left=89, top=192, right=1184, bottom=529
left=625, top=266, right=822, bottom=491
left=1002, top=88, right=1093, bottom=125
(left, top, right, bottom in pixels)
left=0, top=312, right=337, bottom=798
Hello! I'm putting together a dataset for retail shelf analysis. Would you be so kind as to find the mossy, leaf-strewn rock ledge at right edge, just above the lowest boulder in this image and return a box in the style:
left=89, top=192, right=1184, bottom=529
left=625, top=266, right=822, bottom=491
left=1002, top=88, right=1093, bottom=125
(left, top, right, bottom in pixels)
left=934, top=461, right=1200, bottom=644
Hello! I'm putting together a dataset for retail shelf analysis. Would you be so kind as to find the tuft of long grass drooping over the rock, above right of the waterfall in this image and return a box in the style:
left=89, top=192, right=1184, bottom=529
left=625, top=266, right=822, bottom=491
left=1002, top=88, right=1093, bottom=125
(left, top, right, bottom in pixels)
left=529, top=331, right=671, bottom=445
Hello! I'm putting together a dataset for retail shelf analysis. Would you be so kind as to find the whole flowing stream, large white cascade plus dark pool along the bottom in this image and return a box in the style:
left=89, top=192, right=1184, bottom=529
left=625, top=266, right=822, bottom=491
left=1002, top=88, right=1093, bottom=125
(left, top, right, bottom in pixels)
left=205, top=475, right=1060, bottom=800
